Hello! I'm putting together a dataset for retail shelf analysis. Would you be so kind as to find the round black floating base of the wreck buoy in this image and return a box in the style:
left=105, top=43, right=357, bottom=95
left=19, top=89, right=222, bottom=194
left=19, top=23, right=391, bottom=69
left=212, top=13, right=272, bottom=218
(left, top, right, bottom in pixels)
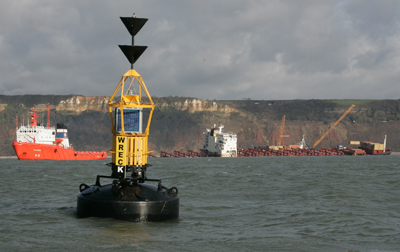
left=77, top=184, right=179, bottom=221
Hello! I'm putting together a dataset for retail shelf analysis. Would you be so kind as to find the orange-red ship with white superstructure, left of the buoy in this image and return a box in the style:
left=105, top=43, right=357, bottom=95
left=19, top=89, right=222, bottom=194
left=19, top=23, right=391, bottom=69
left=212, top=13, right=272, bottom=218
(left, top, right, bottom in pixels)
left=13, top=106, right=107, bottom=160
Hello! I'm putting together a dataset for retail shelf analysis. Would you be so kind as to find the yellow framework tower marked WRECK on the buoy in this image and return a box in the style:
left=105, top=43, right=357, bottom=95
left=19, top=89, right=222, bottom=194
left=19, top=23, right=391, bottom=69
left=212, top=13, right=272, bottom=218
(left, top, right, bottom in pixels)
left=108, top=61, right=154, bottom=180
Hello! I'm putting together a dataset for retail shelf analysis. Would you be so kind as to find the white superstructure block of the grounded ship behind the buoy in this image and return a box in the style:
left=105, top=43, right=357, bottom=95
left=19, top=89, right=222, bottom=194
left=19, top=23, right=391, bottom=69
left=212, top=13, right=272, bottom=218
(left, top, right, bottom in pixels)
left=201, top=124, right=237, bottom=157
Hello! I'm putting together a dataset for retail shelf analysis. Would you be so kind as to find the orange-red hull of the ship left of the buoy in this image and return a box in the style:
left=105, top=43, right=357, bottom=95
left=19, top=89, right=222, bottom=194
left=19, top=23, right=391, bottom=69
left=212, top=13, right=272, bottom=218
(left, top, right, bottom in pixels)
left=13, top=142, right=107, bottom=160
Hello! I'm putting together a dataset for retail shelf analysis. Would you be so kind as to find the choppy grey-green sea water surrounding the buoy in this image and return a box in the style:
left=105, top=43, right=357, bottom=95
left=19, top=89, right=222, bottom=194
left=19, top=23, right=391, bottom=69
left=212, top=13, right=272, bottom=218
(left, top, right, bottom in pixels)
left=0, top=156, right=400, bottom=252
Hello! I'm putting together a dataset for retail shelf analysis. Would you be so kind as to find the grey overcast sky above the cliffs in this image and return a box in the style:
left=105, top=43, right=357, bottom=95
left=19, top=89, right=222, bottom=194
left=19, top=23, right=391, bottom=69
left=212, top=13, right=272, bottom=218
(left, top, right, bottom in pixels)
left=0, top=0, right=400, bottom=100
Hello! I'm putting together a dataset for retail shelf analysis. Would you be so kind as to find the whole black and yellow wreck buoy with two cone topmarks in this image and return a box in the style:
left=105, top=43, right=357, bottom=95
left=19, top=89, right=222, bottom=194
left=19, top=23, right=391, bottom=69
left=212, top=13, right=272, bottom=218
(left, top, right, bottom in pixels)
left=77, top=15, right=179, bottom=221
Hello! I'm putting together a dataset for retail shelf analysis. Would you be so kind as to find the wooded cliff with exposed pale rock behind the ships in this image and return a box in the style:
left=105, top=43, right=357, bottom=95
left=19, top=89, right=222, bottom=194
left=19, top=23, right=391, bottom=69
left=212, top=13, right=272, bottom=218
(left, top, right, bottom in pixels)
left=0, top=95, right=400, bottom=155
